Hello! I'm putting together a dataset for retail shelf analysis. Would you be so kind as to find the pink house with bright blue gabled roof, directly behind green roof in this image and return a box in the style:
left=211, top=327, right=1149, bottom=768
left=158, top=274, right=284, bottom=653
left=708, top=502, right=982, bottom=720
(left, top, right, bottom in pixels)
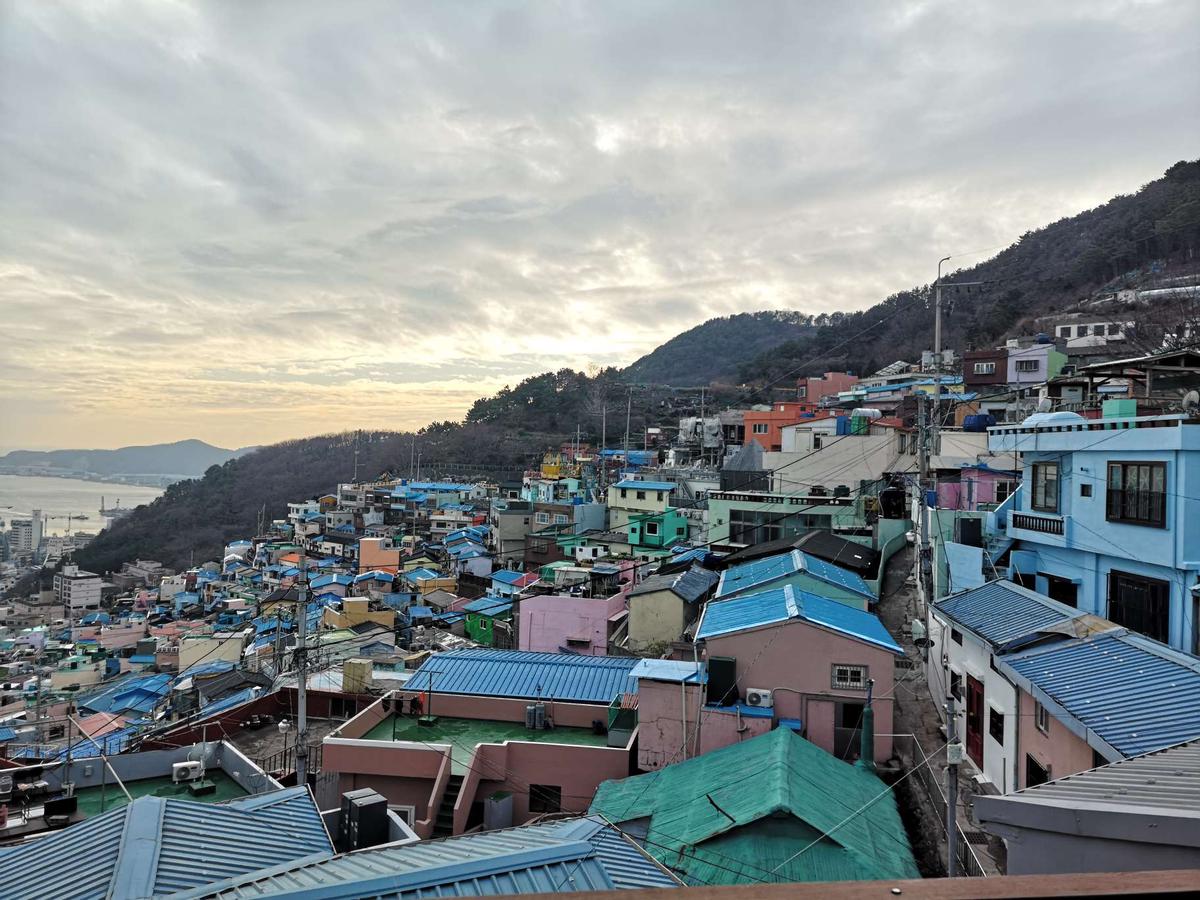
left=632, top=586, right=902, bottom=769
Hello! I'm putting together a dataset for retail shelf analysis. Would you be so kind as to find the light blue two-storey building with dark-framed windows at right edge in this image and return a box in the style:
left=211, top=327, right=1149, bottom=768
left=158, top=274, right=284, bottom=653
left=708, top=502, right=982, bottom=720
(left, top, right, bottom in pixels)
left=988, top=413, right=1200, bottom=654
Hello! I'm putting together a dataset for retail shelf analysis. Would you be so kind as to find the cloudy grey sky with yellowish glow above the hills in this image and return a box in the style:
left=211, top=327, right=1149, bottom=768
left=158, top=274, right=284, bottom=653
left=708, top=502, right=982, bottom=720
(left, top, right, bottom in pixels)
left=0, top=0, right=1200, bottom=448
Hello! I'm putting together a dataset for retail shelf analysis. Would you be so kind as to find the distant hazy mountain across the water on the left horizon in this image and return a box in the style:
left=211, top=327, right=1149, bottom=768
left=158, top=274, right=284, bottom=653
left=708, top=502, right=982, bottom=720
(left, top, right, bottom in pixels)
left=0, top=440, right=254, bottom=475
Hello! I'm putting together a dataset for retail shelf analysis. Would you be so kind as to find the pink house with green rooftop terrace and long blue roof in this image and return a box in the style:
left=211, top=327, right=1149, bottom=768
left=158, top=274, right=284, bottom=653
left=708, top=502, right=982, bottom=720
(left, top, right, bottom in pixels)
left=322, top=649, right=637, bottom=838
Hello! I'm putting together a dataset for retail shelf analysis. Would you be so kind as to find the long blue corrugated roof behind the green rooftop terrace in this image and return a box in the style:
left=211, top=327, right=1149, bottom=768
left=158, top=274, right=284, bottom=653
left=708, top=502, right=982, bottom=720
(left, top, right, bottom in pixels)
left=409, top=648, right=637, bottom=703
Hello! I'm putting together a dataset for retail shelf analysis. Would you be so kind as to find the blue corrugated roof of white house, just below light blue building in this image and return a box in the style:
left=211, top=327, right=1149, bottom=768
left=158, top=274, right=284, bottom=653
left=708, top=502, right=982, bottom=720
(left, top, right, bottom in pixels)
left=934, top=580, right=1084, bottom=647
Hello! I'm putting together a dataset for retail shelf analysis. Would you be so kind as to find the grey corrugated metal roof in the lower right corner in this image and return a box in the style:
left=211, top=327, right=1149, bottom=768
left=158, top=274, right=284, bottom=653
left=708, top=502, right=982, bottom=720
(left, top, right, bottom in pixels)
left=984, top=740, right=1200, bottom=817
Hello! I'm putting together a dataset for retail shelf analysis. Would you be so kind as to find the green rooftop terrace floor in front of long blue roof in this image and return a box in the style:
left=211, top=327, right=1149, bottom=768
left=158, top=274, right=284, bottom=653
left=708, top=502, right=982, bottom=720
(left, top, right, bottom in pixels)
left=361, top=715, right=608, bottom=775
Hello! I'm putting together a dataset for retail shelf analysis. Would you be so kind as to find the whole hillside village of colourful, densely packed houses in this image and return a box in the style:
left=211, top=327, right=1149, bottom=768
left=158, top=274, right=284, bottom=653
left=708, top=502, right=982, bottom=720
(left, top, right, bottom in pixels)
left=0, top=309, right=1200, bottom=898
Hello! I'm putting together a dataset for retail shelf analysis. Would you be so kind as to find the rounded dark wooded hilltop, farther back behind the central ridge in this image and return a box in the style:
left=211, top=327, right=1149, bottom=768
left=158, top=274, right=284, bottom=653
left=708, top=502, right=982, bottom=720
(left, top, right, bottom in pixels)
left=622, top=310, right=814, bottom=386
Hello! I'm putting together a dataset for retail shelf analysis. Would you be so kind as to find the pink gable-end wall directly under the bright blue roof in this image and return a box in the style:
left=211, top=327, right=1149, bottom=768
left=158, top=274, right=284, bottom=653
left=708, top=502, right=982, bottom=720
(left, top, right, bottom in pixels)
left=700, top=620, right=895, bottom=762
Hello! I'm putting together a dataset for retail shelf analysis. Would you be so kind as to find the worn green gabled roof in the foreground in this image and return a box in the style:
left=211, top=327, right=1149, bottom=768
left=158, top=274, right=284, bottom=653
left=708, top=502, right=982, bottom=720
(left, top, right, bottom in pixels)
left=590, top=728, right=920, bottom=884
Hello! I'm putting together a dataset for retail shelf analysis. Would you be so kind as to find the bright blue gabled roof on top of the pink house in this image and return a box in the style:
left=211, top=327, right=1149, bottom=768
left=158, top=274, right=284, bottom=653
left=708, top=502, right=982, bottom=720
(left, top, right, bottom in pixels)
left=696, top=584, right=904, bottom=655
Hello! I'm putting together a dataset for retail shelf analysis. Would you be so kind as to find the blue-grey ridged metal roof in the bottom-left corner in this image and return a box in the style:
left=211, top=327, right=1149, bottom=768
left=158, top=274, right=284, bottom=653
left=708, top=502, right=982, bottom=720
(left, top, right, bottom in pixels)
left=0, top=787, right=334, bottom=900
